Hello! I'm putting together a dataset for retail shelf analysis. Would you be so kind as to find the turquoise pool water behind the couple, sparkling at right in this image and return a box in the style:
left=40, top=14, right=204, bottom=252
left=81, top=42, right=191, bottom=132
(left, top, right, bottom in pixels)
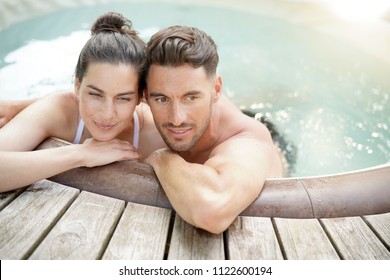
left=0, top=3, right=390, bottom=176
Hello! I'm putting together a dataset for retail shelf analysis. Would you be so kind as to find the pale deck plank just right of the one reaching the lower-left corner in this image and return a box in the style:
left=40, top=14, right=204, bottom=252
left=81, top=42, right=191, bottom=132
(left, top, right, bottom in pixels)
left=30, top=192, right=125, bottom=260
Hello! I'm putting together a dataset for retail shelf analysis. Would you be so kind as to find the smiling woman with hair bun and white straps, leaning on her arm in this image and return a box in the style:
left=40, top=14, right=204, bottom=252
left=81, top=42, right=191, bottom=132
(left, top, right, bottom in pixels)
left=0, top=13, right=165, bottom=192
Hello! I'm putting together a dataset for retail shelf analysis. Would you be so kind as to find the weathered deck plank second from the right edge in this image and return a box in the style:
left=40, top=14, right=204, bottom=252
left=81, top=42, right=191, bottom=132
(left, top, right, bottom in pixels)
left=321, top=217, right=390, bottom=260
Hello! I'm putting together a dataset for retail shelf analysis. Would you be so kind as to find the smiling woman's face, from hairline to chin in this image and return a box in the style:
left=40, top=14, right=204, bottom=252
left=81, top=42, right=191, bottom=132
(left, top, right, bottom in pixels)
left=75, top=63, right=139, bottom=141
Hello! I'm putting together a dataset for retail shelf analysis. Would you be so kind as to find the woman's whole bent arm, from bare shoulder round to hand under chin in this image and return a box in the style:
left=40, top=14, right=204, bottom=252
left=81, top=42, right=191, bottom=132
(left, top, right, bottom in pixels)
left=0, top=95, right=139, bottom=192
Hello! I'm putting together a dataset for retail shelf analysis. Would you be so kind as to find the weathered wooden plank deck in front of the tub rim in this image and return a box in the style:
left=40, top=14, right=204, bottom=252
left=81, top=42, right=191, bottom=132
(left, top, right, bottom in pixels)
left=0, top=180, right=390, bottom=260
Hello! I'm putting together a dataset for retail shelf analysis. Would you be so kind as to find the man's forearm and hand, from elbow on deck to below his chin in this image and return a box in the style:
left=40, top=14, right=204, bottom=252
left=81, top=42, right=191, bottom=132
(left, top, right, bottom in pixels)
left=147, top=149, right=234, bottom=233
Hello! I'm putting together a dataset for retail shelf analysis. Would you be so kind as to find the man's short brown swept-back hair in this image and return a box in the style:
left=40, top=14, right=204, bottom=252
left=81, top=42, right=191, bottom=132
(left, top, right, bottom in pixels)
left=147, top=25, right=219, bottom=77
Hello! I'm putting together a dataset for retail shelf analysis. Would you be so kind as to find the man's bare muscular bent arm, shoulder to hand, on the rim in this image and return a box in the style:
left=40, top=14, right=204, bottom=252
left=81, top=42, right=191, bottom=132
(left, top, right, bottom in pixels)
left=146, top=138, right=272, bottom=233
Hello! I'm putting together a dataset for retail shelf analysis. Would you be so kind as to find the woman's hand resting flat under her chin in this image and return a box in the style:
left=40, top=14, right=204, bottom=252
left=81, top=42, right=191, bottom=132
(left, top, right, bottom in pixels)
left=80, top=138, right=140, bottom=167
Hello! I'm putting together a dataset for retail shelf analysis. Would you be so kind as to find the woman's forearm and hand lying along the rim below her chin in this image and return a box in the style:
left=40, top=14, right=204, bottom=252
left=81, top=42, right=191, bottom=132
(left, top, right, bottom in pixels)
left=0, top=139, right=138, bottom=193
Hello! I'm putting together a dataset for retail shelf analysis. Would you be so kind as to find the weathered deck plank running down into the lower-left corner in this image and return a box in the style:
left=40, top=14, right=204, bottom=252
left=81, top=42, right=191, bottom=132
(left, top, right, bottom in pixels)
left=0, top=180, right=79, bottom=259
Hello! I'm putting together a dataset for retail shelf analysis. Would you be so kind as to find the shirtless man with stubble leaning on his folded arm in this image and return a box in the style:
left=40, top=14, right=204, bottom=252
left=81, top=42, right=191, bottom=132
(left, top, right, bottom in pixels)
left=0, top=26, right=282, bottom=233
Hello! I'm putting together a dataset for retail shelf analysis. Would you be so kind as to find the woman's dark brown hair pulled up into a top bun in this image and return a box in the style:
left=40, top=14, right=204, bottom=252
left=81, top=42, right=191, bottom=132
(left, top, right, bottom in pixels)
left=75, top=12, right=146, bottom=96
